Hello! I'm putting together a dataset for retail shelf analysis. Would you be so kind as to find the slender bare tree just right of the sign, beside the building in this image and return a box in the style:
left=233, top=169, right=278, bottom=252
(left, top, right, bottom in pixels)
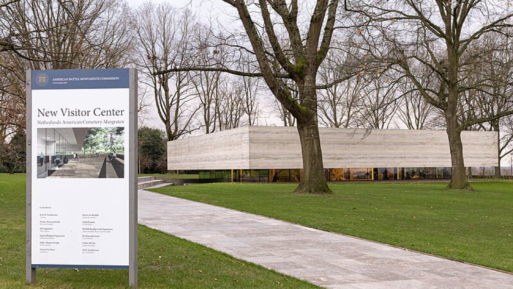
left=133, top=3, right=199, bottom=141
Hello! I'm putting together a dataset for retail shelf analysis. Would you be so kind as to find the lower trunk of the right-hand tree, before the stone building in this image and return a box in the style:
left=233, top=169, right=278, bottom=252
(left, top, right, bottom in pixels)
left=447, top=126, right=472, bottom=190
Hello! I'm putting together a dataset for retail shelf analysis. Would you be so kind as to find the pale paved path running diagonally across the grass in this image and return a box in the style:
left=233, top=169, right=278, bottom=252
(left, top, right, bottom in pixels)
left=139, top=190, right=513, bottom=289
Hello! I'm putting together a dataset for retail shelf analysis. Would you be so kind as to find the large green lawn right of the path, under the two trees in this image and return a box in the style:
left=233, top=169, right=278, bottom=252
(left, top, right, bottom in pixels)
left=155, top=181, right=513, bottom=272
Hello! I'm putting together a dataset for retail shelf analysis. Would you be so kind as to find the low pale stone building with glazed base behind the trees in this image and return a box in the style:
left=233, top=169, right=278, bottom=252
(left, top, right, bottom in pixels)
left=167, top=126, right=498, bottom=182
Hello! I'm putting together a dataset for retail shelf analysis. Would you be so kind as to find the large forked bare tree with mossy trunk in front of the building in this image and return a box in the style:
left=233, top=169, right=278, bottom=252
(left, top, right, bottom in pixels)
left=216, top=0, right=338, bottom=193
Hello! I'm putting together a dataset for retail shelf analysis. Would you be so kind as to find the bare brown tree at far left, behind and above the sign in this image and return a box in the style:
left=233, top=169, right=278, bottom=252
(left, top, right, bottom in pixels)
left=0, top=0, right=132, bottom=136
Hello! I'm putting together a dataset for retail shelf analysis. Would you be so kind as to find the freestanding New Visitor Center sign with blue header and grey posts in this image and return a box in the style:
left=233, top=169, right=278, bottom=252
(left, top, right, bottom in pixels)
left=26, top=69, right=137, bottom=287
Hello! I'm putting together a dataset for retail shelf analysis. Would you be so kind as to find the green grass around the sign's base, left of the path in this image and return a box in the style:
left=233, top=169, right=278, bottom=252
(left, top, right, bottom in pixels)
left=0, top=174, right=318, bottom=289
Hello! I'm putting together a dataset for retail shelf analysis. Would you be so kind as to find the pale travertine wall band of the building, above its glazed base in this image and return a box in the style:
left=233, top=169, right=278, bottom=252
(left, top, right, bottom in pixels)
left=168, top=126, right=497, bottom=170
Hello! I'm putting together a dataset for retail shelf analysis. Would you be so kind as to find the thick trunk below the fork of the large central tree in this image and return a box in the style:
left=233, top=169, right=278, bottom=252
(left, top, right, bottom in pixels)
left=295, top=119, right=331, bottom=194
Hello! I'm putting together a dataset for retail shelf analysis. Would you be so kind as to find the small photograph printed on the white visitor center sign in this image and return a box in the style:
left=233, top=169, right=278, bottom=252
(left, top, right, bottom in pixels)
left=36, top=127, right=125, bottom=178
